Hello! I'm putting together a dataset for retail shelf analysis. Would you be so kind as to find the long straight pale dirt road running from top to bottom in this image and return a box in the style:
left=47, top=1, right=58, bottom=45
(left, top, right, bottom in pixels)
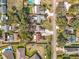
left=51, top=0, right=57, bottom=59
